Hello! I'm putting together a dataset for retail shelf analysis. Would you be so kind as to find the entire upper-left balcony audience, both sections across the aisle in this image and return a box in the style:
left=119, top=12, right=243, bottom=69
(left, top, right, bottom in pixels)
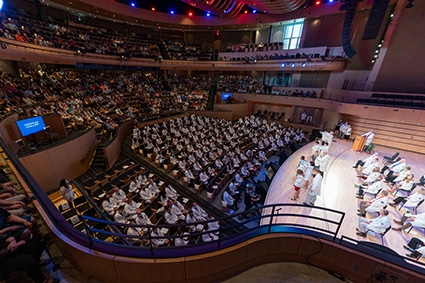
left=0, top=8, right=219, bottom=61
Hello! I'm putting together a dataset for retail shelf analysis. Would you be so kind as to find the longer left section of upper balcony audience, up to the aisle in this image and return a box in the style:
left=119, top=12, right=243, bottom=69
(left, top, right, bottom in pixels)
left=0, top=11, right=160, bottom=59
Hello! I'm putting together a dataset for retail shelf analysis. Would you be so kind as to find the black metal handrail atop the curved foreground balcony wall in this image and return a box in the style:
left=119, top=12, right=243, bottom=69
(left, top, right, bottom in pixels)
left=78, top=204, right=345, bottom=255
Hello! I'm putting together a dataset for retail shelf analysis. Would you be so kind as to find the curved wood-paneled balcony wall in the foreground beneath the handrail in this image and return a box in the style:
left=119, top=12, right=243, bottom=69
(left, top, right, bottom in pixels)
left=46, top=233, right=425, bottom=283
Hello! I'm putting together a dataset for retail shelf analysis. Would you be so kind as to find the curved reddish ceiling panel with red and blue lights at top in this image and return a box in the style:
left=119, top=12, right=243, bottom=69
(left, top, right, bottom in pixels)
left=39, top=0, right=340, bottom=30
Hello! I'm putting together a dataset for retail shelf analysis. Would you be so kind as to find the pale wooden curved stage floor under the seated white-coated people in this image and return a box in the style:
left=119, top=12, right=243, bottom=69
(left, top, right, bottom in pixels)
left=265, top=139, right=425, bottom=262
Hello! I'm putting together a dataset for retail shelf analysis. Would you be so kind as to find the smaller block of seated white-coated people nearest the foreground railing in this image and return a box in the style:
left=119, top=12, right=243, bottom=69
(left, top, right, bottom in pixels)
left=102, top=170, right=219, bottom=247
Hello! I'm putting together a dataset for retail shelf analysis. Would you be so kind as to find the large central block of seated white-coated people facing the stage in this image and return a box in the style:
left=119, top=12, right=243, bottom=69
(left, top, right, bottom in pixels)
left=132, top=115, right=305, bottom=204
